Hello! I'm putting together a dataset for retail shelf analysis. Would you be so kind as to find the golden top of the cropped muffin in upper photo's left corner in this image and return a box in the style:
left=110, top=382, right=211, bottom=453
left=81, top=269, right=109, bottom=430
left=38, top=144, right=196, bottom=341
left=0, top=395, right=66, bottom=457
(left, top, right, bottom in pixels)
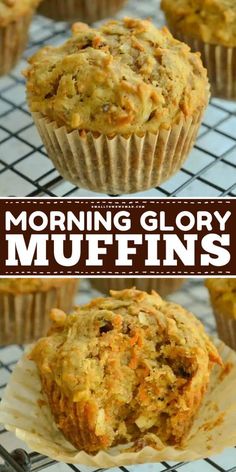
left=0, top=0, right=40, bottom=26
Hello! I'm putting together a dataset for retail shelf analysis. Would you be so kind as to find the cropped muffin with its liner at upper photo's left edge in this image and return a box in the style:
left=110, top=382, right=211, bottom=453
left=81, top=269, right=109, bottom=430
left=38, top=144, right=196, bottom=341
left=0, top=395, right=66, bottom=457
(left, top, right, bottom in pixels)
left=0, top=0, right=39, bottom=76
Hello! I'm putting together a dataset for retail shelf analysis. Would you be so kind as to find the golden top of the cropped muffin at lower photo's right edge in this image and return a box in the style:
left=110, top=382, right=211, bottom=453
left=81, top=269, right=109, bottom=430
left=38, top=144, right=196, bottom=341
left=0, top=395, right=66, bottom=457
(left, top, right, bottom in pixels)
left=206, top=278, right=236, bottom=319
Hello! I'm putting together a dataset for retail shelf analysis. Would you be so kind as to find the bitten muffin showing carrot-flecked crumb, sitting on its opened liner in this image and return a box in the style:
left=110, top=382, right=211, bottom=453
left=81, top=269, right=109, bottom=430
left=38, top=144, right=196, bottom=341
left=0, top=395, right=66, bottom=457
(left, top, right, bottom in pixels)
left=29, top=289, right=221, bottom=454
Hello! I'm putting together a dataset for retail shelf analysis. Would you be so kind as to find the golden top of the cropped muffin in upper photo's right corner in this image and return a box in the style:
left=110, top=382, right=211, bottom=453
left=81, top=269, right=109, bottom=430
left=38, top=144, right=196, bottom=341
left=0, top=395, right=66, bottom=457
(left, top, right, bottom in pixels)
left=162, top=0, right=236, bottom=47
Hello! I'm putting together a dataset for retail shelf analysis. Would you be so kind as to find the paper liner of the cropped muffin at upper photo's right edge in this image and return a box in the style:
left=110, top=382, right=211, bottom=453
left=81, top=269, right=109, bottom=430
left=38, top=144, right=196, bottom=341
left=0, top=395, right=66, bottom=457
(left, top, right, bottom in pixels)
left=171, top=27, right=236, bottom=100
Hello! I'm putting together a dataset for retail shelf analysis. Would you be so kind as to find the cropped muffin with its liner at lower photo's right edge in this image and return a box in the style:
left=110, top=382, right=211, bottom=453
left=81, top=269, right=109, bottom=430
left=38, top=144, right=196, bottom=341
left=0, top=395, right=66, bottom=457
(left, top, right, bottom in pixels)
left=206, top=278, right=236, bottom=349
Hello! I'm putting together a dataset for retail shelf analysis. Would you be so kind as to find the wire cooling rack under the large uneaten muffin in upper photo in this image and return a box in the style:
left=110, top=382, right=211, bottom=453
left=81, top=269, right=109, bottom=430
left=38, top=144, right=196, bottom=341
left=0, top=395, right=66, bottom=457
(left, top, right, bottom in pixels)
left=0, top=0, right=236, bottom=198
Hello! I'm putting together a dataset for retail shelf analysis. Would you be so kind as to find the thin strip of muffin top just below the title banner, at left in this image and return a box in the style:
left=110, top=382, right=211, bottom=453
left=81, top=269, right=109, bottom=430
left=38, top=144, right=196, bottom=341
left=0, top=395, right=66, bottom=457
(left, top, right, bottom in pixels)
left=0, top=277, right=74, bottom=294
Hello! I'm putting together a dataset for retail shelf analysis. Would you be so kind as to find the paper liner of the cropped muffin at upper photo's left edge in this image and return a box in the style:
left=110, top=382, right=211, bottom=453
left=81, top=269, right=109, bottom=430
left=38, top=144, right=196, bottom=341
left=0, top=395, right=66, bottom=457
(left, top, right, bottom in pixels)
left=0, top=11, right=33, bottom=76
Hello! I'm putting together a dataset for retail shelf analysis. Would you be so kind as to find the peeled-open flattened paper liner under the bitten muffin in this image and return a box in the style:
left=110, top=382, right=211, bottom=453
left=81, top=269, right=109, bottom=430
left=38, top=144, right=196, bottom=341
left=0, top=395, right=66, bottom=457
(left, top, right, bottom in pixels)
left=0, top=340, right=236, bottom=468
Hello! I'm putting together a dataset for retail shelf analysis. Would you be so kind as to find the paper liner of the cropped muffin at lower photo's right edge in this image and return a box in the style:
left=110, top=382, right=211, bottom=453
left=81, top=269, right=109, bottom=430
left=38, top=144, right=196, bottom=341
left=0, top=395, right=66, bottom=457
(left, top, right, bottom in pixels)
left=214, top=309, right=236, bottom=350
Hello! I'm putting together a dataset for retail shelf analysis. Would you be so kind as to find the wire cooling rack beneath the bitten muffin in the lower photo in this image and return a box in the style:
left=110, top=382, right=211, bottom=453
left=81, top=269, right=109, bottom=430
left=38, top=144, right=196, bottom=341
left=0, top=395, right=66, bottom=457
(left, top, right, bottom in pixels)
left=0, top=279, right=236, bottom=472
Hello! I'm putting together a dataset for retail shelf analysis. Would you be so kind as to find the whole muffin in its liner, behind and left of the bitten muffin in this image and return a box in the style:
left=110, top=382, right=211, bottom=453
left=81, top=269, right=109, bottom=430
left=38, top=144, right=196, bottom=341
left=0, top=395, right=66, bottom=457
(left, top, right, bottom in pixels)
left=0, top=278, right=77, bottom=345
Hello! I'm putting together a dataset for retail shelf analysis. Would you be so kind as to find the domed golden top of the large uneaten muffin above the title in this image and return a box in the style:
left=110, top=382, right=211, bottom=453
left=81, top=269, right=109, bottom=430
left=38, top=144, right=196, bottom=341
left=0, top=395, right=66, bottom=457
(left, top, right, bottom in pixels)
left=25, top=18, right=209, bottom=136
